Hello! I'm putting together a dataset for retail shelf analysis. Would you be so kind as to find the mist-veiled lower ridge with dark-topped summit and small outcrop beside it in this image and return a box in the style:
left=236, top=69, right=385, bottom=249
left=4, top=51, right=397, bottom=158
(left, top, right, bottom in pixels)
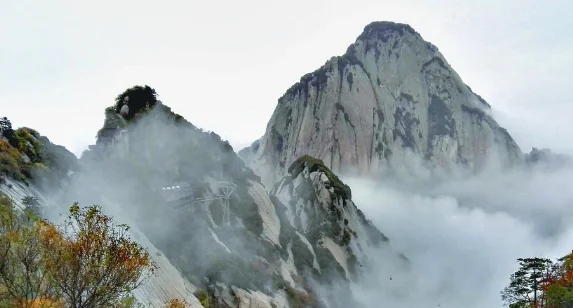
left=0, top=86, right=409, bottom=308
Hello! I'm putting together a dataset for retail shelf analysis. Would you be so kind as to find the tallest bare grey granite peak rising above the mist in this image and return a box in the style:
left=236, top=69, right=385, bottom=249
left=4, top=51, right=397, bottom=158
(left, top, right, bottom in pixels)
left=240, top=22, right=523, bottom=186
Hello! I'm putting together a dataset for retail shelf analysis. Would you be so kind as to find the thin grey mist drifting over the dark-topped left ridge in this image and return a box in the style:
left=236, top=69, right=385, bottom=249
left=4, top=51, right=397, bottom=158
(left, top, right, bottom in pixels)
left=38, top=107, right=278, bottom=296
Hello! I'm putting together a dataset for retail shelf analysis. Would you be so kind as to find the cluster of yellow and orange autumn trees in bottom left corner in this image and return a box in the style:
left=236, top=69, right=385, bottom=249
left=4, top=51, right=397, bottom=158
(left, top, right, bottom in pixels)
left=0, top=196, right=156, bottom=308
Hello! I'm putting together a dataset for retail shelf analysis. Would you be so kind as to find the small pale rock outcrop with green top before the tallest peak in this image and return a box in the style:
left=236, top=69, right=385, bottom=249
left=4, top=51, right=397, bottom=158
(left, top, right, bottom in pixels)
left=271, top=156, right=408, bottom=288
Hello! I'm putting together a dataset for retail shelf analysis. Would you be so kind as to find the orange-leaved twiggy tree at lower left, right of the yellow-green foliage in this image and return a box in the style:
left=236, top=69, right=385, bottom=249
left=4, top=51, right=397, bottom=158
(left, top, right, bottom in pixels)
left=42, top=203, right=156, bottom=308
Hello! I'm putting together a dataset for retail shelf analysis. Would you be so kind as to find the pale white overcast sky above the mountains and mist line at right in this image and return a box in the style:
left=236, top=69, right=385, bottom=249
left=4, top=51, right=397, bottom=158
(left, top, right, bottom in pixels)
left=0, top=0, right=573, bottom=154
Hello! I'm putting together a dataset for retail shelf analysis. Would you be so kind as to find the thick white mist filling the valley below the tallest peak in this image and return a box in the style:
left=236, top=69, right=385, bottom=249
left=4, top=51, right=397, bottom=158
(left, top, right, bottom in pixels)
left=342, top=159, right=573, bottom=308
